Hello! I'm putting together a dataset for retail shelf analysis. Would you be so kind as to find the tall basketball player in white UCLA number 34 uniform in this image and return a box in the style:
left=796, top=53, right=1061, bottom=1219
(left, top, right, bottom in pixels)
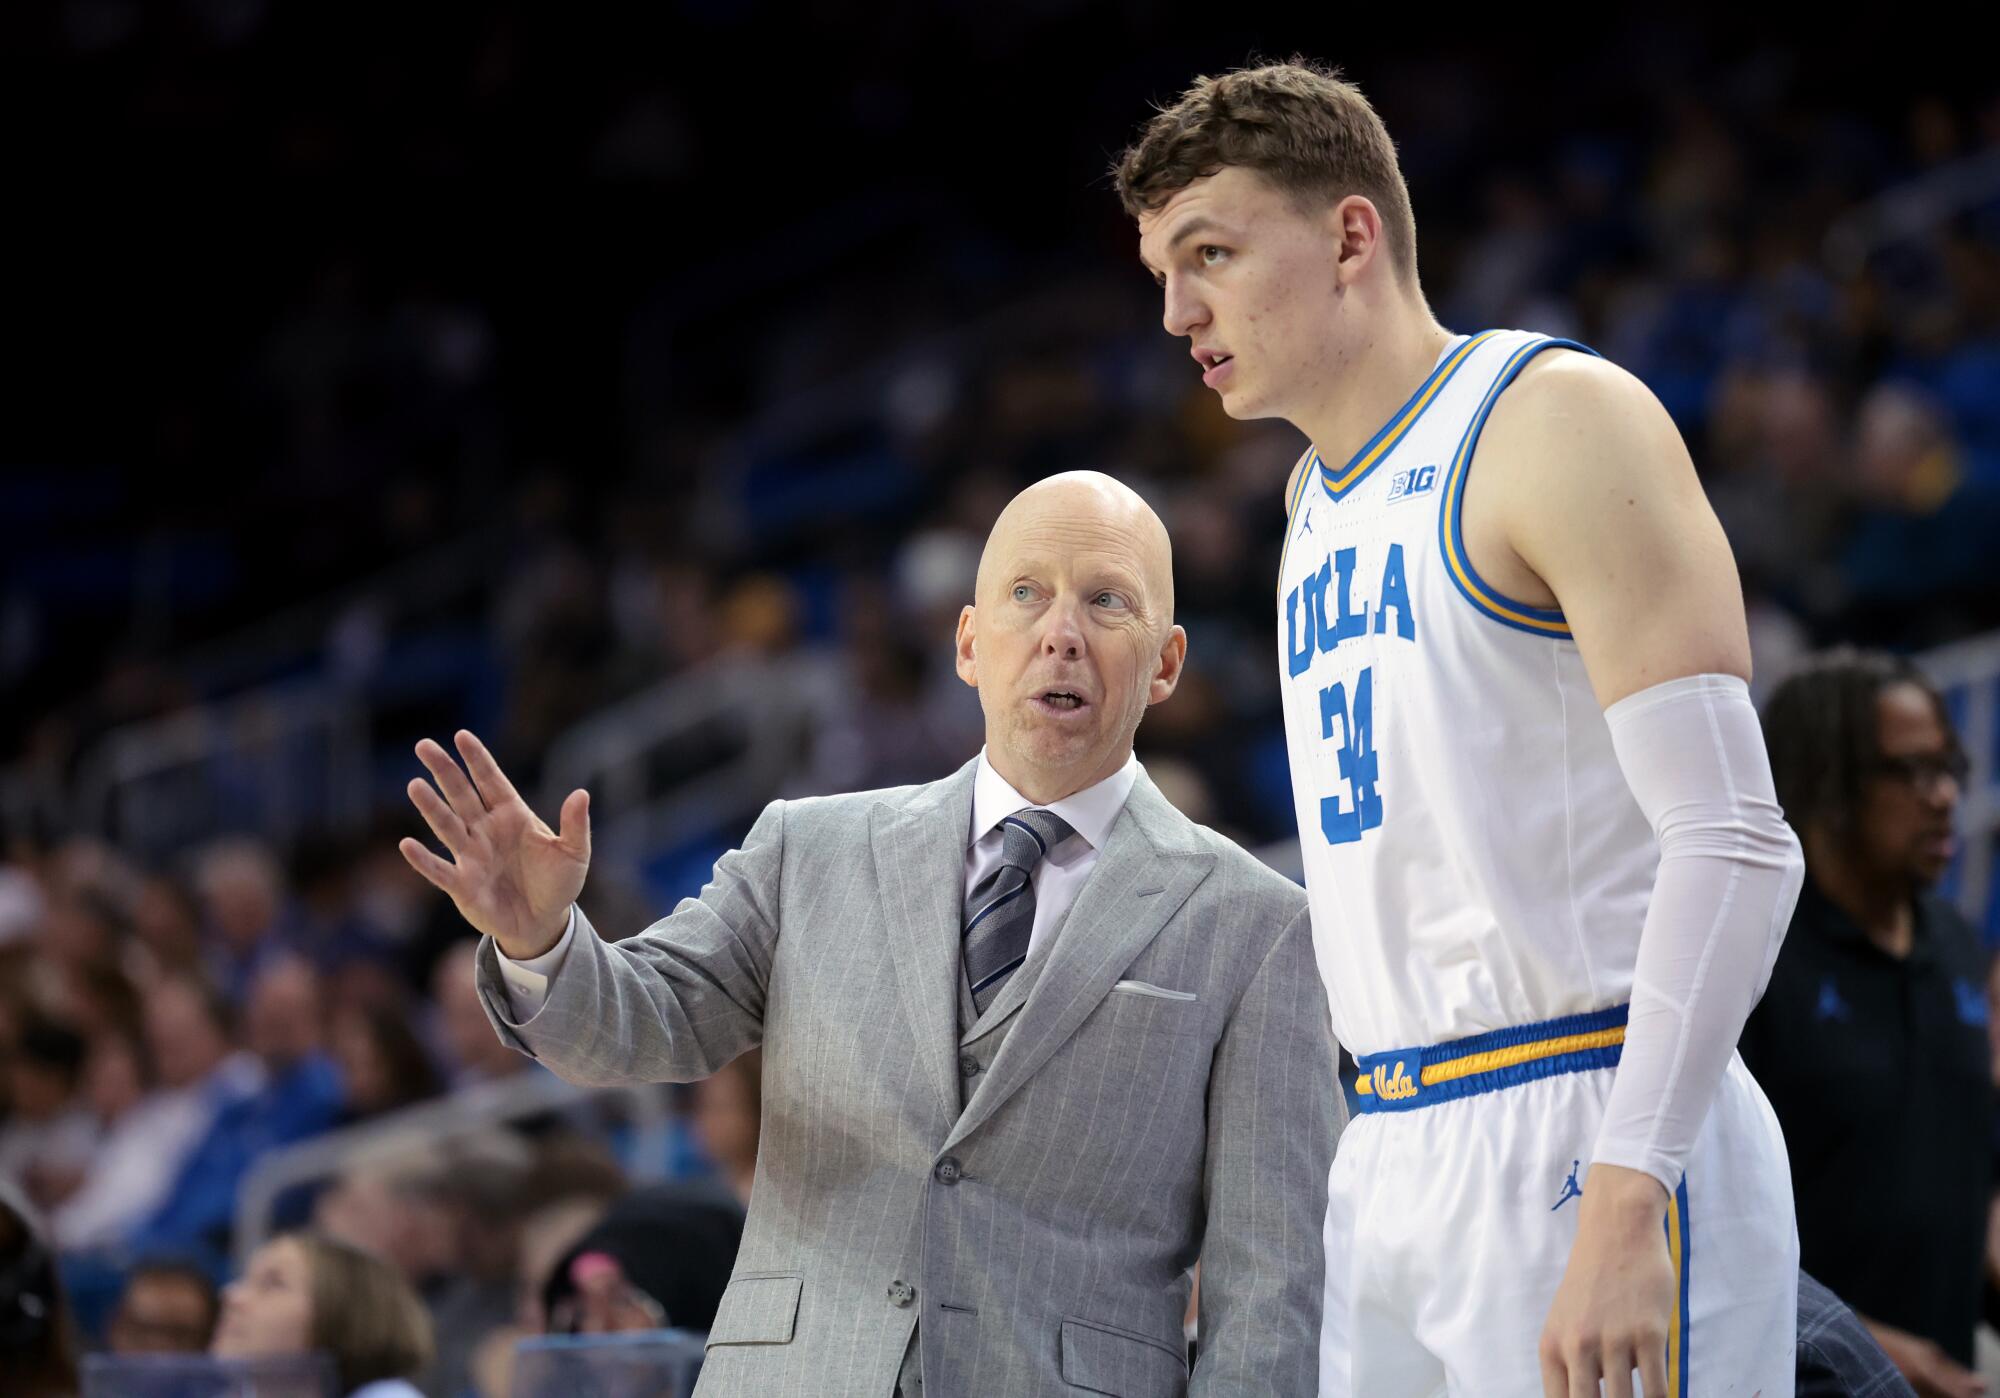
left=1116, top=62, right=1816, bottom=1398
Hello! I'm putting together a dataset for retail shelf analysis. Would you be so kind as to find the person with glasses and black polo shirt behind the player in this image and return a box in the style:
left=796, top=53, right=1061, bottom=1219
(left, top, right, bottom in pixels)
left=1742, top=650, right=1994, bottom=1398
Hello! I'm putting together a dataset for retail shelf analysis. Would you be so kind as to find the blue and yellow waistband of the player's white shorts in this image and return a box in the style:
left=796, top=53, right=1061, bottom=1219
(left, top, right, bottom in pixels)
left=1354, top=1004, right=1630, bottom=1112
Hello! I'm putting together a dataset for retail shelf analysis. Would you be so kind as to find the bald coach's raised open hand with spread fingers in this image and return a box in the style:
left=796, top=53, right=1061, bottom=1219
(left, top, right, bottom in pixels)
left=396, top=728, right=590, bottom=960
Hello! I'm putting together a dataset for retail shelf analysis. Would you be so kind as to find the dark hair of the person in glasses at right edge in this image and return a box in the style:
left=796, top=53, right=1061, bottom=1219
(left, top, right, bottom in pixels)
left=1764, top=646, right=1952, bottom=836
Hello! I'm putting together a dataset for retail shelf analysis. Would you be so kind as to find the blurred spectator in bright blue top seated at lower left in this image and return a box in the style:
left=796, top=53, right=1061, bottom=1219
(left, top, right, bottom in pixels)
left=132, top=956, right=342, bottom=1258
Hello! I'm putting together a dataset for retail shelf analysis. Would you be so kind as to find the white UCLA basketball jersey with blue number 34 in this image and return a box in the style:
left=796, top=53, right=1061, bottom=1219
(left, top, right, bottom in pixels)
left=1278, top=330, right=1658, bottom=1054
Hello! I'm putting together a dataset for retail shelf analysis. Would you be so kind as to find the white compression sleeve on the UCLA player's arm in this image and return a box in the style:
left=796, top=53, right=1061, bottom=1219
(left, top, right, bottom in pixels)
left=1592, top=674, right=1806, bottom=1192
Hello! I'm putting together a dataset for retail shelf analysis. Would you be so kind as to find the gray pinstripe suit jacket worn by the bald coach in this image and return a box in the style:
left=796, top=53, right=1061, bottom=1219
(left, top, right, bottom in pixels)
left=478, top=764, right=1342, bottom=1398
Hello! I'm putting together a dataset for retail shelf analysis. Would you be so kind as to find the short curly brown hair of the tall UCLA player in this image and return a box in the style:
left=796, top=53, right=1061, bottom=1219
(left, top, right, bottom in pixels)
left=1112, top=56, right=1416, bottom=286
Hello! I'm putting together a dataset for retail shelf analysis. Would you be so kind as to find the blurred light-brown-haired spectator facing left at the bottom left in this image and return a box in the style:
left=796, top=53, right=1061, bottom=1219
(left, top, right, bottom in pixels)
left=210, top=1232, right=432, bottom=1398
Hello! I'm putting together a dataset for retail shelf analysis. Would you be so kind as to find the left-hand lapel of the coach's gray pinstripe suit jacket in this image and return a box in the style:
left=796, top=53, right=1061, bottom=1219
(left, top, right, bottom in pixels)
left=870, top=760, right=976, bottom=1120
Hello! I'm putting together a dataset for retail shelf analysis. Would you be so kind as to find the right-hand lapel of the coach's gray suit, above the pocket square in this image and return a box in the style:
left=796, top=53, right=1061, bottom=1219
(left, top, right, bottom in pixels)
left=944, top=774, right=1214, bottom=1150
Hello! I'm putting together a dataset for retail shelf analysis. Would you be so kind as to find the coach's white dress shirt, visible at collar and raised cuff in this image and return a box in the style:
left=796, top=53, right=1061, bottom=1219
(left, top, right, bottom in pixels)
left=494, top=748, right=1140, bottom=1022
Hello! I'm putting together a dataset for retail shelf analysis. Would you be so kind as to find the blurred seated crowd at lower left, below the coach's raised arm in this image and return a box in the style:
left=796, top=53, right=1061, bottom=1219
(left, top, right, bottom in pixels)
left=0, top=820, right=758, bottom=1394
